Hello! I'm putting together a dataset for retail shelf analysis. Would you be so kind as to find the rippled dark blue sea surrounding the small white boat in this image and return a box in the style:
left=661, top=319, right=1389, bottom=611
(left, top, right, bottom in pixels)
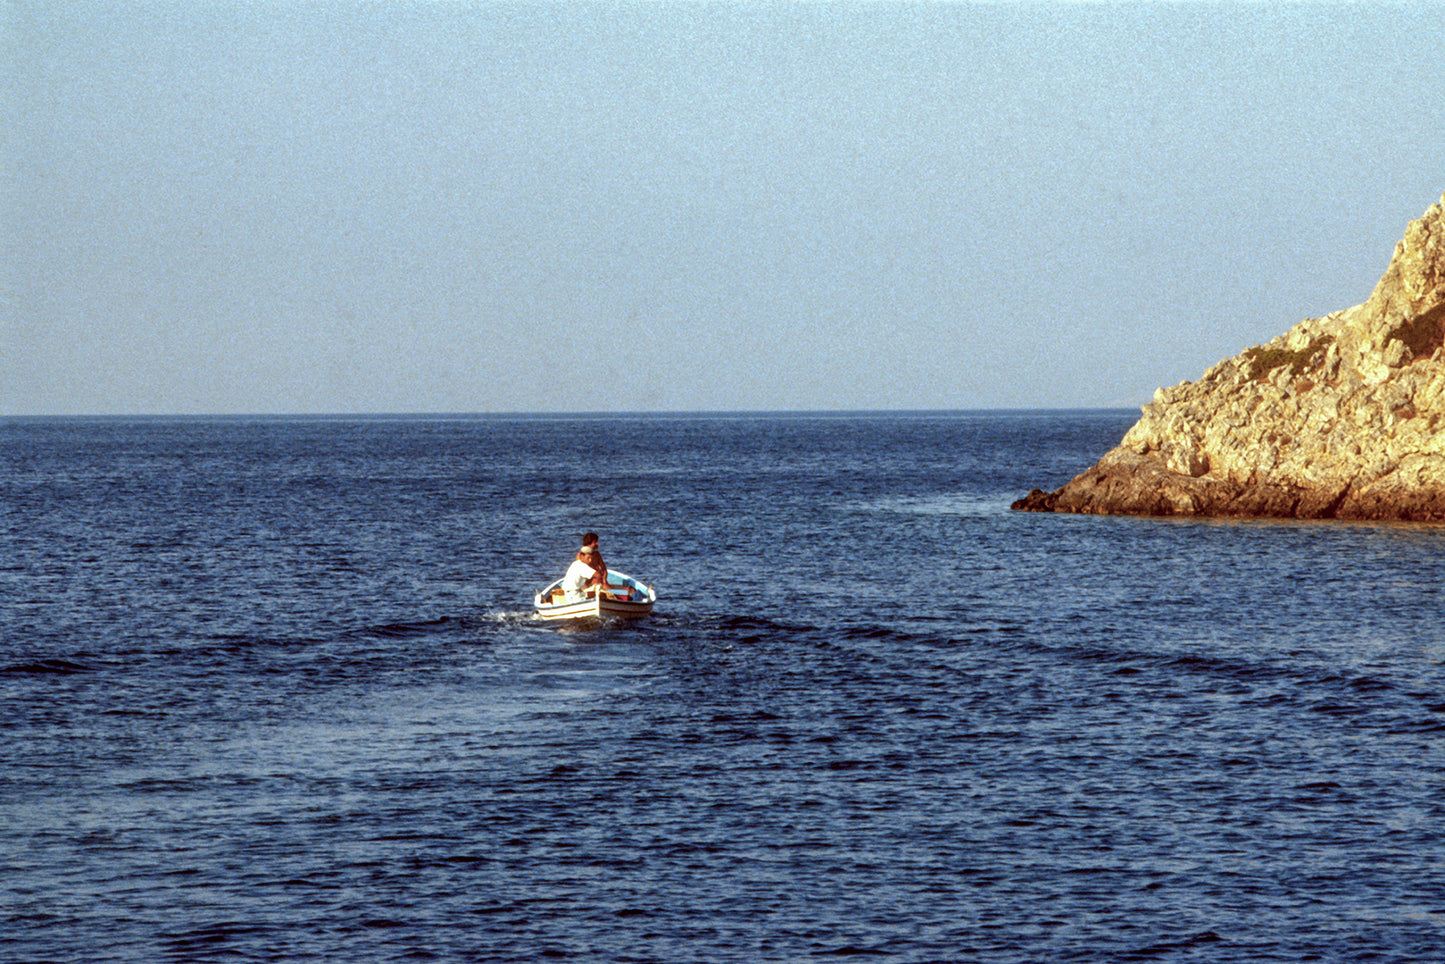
left=0, top=412, right=1445, bottom=963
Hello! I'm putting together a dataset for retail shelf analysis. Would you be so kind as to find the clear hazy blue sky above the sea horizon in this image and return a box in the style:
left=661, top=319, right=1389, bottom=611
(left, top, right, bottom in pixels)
left=0, top=0, right=1445, bottom=416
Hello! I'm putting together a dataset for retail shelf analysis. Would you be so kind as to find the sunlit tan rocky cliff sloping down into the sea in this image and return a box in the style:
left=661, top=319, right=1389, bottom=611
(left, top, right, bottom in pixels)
left=1013, top=197, right=1445, bottom=520
